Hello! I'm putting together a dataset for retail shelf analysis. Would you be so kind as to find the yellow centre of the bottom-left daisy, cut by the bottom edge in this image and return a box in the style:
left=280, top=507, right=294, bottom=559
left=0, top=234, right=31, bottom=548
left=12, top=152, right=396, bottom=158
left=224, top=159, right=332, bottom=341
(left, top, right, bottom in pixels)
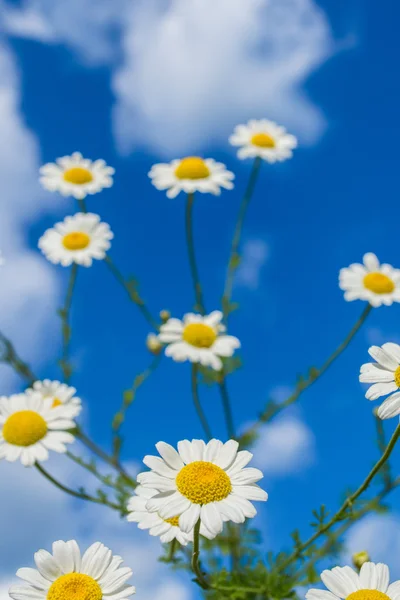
left=47, top=573, right=103, bottom=600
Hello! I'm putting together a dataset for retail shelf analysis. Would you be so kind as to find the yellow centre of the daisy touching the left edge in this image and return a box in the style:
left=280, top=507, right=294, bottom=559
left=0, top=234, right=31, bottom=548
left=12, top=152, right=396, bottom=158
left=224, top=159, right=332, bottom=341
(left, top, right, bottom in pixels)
left=3, top=410, right=47, bottom=447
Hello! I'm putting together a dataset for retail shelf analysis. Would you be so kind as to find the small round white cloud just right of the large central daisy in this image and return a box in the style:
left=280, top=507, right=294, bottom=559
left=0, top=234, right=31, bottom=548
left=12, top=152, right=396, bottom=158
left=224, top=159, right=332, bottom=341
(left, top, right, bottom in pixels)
left=252, top=414, right=315, bottom=477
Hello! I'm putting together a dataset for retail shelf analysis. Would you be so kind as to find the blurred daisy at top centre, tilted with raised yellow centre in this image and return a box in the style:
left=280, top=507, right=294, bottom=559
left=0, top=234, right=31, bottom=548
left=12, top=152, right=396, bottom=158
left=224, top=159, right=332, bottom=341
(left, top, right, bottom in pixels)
left=149, top=156, right=235, bottom=198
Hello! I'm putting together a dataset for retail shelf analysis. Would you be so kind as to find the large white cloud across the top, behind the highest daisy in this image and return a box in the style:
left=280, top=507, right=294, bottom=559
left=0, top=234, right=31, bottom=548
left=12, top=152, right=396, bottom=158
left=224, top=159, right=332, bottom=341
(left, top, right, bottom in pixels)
left=0, top=0, right=336, bottom=156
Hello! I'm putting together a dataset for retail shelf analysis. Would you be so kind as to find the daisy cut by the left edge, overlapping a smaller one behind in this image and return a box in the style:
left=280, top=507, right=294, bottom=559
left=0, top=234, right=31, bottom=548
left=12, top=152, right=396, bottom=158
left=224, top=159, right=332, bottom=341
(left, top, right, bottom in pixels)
left=0, top=392, right=75, bottom=467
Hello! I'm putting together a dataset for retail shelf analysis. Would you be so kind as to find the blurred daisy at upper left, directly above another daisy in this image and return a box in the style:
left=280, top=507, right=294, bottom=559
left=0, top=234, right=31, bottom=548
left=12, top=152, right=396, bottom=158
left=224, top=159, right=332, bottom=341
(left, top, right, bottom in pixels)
left=40, top=152, right=115, bottom=200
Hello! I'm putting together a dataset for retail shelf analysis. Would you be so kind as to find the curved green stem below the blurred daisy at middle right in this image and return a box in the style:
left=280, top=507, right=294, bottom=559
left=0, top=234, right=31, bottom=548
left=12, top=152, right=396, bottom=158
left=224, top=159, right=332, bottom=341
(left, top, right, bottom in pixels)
left=239, top=304, right=372, bottom=445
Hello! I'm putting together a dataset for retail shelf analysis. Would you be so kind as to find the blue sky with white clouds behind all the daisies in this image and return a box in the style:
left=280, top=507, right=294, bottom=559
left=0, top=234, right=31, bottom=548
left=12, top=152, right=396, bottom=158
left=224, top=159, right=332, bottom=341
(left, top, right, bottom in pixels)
left=0, top=0, right=400, bottom=600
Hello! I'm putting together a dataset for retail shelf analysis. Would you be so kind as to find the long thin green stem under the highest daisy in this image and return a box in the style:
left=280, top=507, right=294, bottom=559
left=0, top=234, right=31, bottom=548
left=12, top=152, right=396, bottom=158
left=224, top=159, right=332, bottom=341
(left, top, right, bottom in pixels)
left=222, top=157, right=262, bottom=319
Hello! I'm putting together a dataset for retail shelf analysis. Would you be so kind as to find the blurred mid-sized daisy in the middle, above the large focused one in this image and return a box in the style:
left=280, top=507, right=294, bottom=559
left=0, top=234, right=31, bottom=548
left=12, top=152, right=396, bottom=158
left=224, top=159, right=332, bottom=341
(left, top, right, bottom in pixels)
left=158, top=310, right=240, bottom=371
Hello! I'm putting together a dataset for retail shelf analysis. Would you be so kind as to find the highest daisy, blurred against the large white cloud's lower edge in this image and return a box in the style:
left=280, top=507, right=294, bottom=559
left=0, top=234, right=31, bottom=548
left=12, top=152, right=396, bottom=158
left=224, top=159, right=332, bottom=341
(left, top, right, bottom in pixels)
left=229, top=119, right=297, bottom=163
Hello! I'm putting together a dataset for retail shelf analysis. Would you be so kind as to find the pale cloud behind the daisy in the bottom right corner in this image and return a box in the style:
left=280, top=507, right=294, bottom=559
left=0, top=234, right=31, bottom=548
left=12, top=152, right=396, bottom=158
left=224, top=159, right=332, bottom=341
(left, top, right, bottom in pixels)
left=343, top=514, right=400, bottom=581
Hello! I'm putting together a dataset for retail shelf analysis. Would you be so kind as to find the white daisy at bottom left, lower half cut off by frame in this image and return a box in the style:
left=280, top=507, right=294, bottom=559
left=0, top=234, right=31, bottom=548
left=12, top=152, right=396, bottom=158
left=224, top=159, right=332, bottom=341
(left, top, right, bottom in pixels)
left=9, top=540, right=135, bottom=600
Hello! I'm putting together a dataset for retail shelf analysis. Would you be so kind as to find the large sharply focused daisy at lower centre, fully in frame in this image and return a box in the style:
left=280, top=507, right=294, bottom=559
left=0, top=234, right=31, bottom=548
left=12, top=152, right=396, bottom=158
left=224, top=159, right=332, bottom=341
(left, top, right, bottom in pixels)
left=137, top=440, right=268, bottom=539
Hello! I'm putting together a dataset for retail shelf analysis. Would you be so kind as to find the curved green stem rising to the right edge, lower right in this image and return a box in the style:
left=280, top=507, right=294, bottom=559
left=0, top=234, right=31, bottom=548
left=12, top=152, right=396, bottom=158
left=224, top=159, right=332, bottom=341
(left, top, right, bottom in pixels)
left=279, top=425, right=400, bottom=572
